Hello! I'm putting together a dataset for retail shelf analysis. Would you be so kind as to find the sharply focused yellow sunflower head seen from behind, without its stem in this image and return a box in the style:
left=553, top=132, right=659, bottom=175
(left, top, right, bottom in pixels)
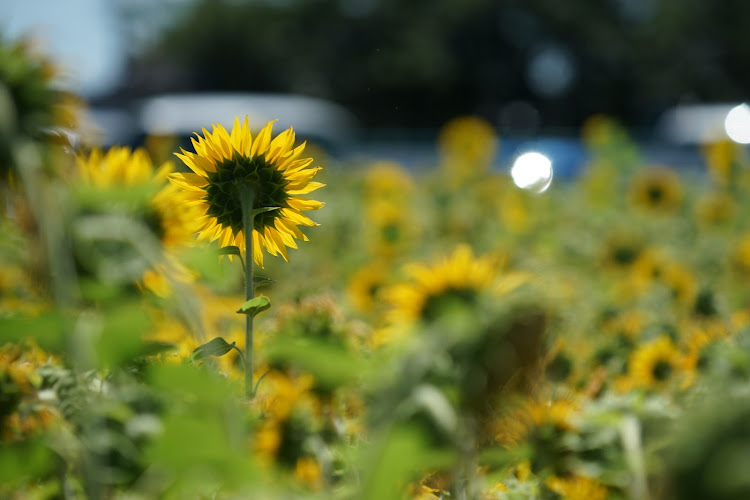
left=169, top=117, right=324, bottom=267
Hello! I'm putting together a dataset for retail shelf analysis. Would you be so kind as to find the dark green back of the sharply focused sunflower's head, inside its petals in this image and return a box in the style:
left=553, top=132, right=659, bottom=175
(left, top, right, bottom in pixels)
left=204, top=152, right=289, bottom=235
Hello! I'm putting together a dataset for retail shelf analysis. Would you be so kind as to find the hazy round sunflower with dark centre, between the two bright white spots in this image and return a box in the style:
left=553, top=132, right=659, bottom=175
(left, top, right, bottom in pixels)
left=630, top=167, right=683, bottom=212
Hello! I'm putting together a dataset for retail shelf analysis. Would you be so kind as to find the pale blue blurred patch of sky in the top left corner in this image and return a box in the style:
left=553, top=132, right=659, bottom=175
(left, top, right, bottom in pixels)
left=0, top=0, right=127, bottom=98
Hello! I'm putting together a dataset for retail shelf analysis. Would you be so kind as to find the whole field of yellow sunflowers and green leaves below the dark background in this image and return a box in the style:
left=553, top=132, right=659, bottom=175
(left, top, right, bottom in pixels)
left=0, top=36, right=750, bottom=500
